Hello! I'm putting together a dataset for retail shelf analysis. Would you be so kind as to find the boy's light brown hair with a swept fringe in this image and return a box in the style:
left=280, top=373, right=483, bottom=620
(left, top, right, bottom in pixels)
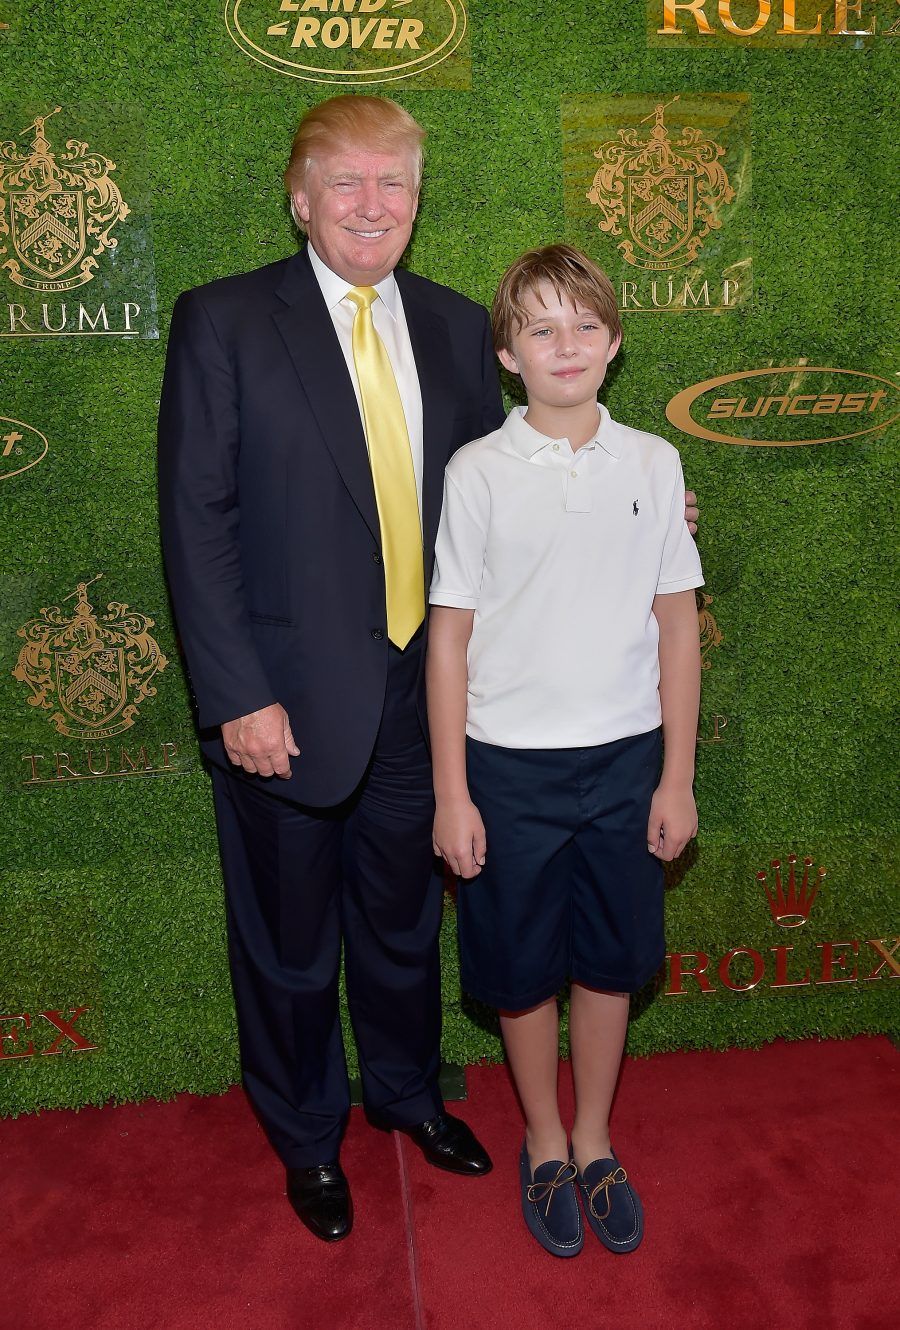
left=491, top=245, right=622, bottom=351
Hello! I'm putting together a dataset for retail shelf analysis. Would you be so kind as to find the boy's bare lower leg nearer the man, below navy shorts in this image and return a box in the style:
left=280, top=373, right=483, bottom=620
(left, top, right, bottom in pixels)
left=500, top=998, right=569, bottom=1173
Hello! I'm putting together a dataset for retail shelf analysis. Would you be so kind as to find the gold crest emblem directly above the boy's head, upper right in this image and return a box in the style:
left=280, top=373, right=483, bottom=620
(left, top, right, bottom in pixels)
left=586, top=96, right=735, bottom=271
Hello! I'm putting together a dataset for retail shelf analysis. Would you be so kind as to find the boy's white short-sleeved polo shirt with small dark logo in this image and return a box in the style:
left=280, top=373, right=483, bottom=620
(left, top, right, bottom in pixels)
left=429, top=406, right=703, bottom=749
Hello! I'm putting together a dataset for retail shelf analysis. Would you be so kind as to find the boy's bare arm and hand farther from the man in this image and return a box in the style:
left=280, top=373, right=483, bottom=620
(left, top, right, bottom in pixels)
left=647, top=589, right=701, bottom=861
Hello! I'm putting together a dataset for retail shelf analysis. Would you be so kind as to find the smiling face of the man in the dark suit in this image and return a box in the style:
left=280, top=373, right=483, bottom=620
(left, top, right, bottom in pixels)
left=294, top=148, right=419, bottom=286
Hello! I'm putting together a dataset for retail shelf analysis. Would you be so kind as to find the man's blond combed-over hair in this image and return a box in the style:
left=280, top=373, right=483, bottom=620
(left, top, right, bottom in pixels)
left=284, top=96, right=425, bottom=226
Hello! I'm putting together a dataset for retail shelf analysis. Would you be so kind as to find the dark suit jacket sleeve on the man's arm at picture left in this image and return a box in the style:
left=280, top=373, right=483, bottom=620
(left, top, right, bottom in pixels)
left=158, top=291, right=277, bottom=728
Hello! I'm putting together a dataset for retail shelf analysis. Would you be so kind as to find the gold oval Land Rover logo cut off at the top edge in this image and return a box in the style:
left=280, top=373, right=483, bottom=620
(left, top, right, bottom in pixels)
left=225, top=0, right=468, bottom=85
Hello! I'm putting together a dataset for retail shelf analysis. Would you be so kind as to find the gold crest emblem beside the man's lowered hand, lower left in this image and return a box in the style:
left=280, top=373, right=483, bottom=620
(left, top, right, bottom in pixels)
left=12, top=573, right=169, bottom=739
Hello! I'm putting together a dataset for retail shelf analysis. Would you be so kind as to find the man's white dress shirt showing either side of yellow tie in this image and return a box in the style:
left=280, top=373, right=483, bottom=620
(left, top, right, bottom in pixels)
left=307, top=245, right=423, bottom=517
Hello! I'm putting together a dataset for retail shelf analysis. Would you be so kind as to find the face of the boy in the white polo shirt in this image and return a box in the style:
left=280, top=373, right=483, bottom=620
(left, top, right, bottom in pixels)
left=497, top=282, right=621, bottom=407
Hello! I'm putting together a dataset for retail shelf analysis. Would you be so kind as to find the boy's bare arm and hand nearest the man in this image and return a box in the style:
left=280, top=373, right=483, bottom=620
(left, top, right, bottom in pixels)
left=425, top=605, right=485, bottom=878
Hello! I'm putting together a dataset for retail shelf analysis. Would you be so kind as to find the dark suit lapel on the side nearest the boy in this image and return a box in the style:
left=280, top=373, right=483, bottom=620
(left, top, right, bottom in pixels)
left=395, top=269, right=453, bottom=569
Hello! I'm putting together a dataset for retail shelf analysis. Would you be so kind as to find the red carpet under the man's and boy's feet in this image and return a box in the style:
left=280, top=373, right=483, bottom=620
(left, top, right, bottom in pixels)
left=0, top=1037, right=900, bottom=1330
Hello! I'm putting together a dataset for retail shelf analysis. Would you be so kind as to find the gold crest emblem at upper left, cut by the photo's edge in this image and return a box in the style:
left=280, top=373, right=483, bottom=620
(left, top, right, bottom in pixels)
left=0, top=106, right=130, bottom=291
